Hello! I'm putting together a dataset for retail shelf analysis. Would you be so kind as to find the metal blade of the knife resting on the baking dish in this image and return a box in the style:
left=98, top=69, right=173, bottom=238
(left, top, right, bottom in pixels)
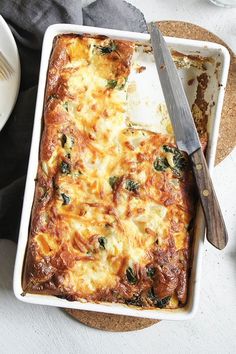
left=150, top=23, right=201, bottom=155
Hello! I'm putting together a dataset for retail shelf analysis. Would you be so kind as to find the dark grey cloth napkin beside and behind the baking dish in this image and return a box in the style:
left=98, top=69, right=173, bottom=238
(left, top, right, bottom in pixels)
left=0, top=0, right=147, bottom=241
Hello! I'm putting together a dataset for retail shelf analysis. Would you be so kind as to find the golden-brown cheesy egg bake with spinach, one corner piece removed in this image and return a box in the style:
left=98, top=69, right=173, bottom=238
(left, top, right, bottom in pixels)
left=24, top=35, right=197, bottom=307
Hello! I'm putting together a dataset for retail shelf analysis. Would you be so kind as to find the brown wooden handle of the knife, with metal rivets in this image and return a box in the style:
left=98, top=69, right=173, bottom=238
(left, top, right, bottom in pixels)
left=190, top=148, right=228, bottom=250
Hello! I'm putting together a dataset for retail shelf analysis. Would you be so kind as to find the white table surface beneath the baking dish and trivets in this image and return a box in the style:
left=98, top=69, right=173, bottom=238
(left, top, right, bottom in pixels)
left=0, top=0, right=236, bottom=354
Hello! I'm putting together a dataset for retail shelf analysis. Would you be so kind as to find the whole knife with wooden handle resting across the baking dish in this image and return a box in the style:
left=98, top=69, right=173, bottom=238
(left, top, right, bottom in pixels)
left=150, top=23, right=228, bottom=250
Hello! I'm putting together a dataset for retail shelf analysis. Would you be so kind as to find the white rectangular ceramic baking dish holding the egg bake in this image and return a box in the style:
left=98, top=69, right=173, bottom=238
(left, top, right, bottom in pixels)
left=13, top=24, right=230, bottom=320
